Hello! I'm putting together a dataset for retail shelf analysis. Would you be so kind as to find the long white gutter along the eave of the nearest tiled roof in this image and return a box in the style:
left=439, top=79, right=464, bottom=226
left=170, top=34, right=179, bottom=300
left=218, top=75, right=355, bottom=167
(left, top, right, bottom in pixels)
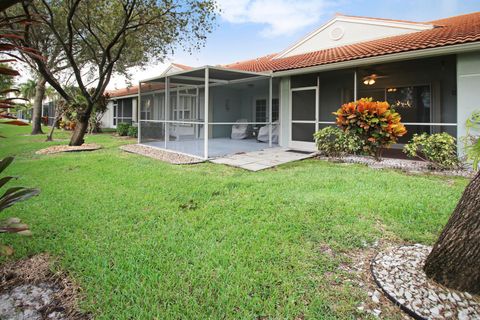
left=273, top=41, right=480, bottom=77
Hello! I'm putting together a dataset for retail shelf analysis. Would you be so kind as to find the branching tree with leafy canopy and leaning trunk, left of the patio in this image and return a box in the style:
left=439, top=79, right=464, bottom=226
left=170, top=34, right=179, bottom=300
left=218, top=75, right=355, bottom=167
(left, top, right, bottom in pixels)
left=14, top=0, right=217, bottom=145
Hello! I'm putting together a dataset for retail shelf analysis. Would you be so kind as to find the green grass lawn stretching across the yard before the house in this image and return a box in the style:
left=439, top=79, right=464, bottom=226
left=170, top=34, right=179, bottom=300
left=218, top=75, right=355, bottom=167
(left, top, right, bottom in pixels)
left=0, top=125, right=467, bottom=319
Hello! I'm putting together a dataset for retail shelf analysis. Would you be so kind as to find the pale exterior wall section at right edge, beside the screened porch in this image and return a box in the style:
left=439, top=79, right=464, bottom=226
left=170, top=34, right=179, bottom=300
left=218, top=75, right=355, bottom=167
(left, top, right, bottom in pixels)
left=457, top=52, right=480, bottom=154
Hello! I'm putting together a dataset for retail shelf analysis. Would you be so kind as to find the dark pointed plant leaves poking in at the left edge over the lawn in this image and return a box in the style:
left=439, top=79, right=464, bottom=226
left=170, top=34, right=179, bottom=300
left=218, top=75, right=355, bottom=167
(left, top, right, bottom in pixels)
left=0, top=157, right=40, bottom=255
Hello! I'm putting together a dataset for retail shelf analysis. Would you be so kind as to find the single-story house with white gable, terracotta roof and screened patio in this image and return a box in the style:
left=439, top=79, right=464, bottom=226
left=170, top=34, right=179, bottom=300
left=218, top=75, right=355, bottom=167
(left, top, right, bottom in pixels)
left=105, top=12, right=480, bottom=158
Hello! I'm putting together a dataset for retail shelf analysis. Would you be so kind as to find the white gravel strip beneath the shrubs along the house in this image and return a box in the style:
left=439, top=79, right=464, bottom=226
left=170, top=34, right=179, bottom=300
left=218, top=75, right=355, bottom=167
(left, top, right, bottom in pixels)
left=318, top=155, right=475, bottom=178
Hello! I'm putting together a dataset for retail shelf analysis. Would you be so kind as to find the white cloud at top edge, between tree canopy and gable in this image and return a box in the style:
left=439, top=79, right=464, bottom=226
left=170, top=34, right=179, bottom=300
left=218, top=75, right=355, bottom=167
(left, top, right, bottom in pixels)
left=217, top=0, right=328, bottom=37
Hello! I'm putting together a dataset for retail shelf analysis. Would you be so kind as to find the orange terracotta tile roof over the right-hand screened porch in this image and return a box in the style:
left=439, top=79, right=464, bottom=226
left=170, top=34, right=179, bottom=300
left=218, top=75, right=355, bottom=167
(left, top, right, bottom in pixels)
left=225, top=12, right=480, bottom=72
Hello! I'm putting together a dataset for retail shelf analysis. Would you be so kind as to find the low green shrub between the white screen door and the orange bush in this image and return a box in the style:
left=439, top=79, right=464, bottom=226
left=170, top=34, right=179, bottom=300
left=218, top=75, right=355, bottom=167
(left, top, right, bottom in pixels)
left=313, top=127, right=362, bottom=157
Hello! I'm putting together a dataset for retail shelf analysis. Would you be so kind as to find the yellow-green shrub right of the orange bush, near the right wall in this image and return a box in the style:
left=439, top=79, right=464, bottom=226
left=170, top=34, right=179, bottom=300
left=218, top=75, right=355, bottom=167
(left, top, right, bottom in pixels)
left=403, top=132, right=459, bottom=170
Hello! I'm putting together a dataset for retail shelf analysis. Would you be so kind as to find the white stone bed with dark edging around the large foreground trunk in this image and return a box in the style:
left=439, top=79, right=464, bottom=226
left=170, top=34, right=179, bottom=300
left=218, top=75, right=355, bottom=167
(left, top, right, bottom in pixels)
left=371, top=244, right=480, bottom=320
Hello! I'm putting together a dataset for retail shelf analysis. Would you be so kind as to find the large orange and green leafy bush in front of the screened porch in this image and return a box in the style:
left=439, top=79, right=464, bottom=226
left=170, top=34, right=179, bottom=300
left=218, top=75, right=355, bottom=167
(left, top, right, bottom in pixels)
left=333, top=98, right=407, bottom=159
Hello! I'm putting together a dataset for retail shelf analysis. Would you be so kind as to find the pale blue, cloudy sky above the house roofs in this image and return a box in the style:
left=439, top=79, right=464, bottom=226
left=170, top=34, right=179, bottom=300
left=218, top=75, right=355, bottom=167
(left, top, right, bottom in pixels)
left=108, top=0, right=480, bottom=89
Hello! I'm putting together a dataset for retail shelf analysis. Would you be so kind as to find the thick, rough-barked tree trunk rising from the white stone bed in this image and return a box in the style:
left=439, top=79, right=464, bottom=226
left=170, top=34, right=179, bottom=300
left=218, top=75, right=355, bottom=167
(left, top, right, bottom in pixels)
left=424, top=172, right=480, bottom=294
